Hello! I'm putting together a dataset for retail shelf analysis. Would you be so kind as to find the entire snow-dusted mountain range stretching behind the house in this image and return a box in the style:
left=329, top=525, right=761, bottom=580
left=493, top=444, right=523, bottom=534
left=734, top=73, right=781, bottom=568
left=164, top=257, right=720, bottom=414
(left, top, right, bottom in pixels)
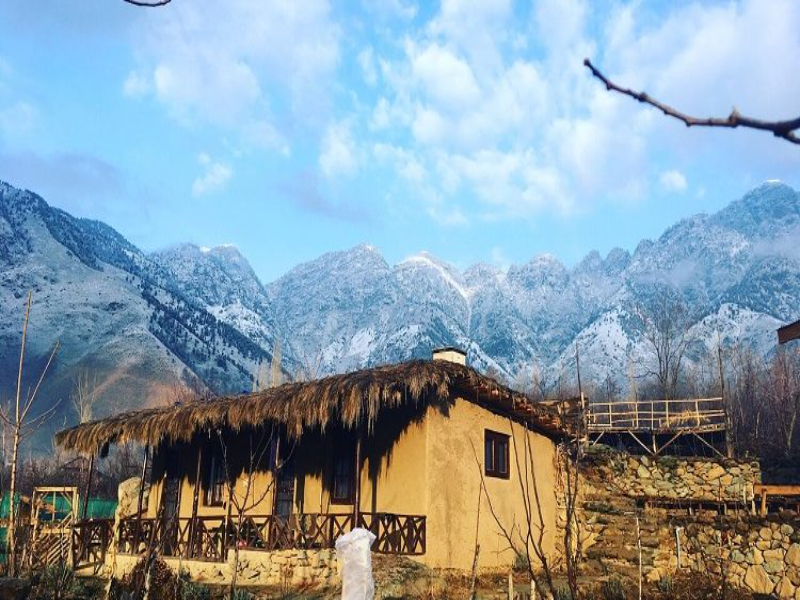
left=0, top=182, right=800, bottom=446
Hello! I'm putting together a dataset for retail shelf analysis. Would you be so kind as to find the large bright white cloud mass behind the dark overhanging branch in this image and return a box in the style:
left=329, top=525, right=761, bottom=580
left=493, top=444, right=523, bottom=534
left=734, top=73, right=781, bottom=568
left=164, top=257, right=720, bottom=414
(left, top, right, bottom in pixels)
left=369, top=0, right=800, bottom=227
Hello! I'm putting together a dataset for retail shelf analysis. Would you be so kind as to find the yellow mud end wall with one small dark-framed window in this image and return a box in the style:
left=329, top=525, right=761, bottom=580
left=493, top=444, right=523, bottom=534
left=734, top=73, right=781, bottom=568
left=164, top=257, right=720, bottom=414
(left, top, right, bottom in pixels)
left=423, top=399, right=556, bottom=569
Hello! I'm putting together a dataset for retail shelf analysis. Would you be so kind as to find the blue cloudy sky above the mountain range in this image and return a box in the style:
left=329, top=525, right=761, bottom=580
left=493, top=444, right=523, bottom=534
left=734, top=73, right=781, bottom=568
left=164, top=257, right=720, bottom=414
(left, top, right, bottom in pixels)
left=0, top=0, right=800, bottom=281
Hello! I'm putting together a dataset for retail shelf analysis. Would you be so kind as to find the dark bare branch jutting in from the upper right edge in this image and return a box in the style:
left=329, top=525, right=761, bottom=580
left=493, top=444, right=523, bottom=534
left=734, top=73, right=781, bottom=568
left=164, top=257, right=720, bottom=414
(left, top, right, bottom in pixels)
left=583, top=58, right=800, bottom=144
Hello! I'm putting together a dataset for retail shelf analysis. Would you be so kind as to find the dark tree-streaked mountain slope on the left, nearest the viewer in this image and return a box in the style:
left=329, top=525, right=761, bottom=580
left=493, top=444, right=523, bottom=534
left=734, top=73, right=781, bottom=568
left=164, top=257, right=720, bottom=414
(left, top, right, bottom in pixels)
left=0, top=182, right=272, bottom=450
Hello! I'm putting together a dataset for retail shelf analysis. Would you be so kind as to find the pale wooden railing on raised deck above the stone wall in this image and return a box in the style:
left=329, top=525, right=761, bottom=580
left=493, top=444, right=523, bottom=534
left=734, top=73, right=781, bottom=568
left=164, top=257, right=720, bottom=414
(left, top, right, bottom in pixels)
left=586, top=398, right=726, bottom=433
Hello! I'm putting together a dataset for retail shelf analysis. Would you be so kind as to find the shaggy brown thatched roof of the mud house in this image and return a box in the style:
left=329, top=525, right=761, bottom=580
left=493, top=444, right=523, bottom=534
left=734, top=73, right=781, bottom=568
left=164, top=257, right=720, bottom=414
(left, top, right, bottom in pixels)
left=55, top=360, right=562, bottom=454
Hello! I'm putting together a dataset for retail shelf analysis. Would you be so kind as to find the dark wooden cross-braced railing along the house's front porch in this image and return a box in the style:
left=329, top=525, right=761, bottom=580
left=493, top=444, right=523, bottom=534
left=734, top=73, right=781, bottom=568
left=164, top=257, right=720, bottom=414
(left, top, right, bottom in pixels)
left=119, top=513, right=426, bottom=561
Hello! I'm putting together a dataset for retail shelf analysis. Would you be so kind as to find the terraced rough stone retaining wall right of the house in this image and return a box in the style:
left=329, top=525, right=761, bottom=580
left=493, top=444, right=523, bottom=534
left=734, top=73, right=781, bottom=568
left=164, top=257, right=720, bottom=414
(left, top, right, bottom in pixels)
left=579, top=450, right=800, bottom=600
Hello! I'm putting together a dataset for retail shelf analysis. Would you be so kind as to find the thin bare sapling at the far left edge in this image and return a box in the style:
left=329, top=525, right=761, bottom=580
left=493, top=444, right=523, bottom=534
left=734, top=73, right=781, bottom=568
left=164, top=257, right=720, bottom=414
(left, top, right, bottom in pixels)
left=0, top=292, right=58, bottom=575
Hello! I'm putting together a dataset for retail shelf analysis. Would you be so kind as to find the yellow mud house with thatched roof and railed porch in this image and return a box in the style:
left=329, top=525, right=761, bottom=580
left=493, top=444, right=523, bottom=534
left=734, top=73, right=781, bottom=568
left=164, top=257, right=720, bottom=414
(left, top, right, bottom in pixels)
left=56, top=349, right=561, bottom=580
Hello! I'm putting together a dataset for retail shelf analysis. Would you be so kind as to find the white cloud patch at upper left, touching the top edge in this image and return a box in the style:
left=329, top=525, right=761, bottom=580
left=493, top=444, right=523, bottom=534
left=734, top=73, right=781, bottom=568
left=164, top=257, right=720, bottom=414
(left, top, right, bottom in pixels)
left=123, top=0, right=339, bottom=152
